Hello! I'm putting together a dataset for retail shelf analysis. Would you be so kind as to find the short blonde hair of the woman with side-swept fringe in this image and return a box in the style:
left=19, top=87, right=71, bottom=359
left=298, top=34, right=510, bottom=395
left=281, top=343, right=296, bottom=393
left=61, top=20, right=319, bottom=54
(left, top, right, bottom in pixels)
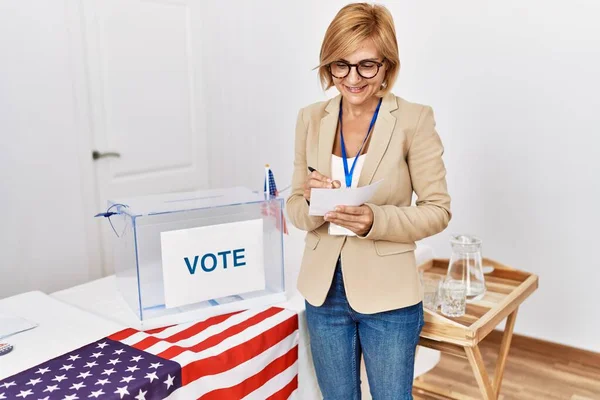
left=318, top=3, right=400, bottom=96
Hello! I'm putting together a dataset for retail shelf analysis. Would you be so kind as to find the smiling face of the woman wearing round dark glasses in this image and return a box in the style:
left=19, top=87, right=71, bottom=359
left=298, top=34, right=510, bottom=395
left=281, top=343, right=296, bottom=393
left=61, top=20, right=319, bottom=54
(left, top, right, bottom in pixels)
left=330, top=39, right=386, bottom=106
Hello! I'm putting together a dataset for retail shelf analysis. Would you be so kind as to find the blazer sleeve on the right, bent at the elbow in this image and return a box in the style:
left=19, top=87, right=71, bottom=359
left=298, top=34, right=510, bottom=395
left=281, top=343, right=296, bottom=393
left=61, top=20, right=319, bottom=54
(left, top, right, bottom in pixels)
left=362, top=107, right=452, bottom=243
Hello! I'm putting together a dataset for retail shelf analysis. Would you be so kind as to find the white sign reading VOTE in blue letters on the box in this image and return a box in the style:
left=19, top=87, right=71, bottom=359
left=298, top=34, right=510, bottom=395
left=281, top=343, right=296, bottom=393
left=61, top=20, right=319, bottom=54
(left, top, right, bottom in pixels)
left=160, top=219, right=265, bottom=308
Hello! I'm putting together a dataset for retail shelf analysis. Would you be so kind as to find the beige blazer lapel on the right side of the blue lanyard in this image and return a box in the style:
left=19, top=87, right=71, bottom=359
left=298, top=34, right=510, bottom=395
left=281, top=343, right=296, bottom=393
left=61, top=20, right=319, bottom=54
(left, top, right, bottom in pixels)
left=356, top=93, right=398, bottom=187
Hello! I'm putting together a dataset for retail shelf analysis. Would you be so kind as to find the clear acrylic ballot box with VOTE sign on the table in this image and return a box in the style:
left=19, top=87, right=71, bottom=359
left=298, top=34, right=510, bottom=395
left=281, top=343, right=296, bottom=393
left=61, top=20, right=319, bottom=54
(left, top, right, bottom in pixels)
left=102, top=187, right=286, bottom=322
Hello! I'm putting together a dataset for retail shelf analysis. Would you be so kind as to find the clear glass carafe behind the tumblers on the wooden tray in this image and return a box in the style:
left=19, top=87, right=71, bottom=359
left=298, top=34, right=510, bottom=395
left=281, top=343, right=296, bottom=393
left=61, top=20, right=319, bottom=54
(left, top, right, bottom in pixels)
left=446, top=235, right=485, bottom=303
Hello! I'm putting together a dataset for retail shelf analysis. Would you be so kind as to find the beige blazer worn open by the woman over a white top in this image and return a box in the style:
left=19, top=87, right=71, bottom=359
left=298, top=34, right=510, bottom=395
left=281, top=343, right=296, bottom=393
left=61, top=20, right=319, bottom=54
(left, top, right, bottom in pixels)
left=286, top=94, right=451, bottom=314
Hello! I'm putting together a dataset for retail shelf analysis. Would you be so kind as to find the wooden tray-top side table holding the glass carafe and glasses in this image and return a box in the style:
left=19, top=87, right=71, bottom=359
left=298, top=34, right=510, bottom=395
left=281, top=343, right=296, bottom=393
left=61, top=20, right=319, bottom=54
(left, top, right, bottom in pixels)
left=414, top=258, right=538, bottom=400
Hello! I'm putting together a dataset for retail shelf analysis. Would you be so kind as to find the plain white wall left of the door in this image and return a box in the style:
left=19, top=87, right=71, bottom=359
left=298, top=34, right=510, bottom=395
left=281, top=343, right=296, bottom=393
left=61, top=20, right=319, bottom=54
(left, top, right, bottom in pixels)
left=0, top=0, right=99, bottom=298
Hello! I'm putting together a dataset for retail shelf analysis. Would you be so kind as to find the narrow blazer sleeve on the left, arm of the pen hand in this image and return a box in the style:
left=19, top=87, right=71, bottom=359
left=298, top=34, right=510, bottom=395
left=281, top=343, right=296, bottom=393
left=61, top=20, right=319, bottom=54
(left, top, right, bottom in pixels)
left=286, top=109, right=325, bottom=231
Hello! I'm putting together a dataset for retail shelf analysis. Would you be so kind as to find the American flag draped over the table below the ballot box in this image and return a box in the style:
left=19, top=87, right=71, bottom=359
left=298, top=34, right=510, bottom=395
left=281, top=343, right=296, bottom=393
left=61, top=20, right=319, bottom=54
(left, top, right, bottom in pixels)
left=0, top=307, right=298, bottom=400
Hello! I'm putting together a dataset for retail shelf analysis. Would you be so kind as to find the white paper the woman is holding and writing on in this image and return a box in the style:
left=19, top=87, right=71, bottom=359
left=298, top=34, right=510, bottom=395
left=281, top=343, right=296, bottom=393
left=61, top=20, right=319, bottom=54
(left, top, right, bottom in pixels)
left=308, top=180, right=383, bottom=216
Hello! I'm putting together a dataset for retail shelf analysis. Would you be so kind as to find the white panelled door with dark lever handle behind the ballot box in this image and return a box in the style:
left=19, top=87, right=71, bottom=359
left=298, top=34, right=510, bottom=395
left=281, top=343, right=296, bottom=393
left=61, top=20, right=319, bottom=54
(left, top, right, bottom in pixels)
left=83, top=0, right=209, bottom=273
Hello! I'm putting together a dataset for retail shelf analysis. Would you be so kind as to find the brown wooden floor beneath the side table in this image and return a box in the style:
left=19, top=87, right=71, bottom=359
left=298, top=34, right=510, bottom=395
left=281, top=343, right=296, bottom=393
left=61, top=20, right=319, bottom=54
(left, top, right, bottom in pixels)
left=414, top=332, right=600, bottom=400
